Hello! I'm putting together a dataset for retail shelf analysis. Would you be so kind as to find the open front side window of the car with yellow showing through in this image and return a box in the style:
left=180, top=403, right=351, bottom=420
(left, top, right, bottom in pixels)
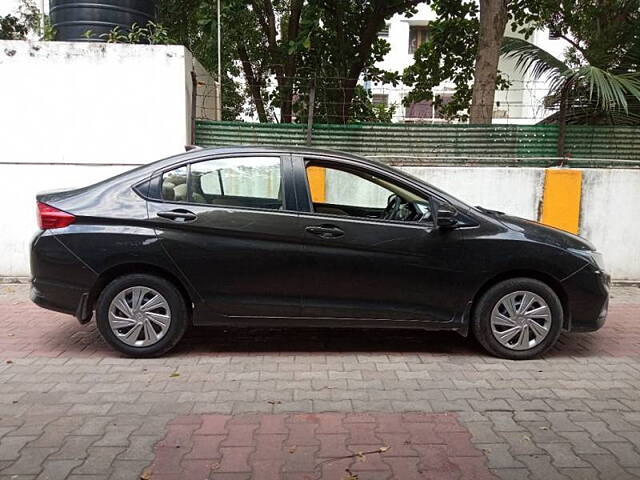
left=307, top=162, right=430, bottom=221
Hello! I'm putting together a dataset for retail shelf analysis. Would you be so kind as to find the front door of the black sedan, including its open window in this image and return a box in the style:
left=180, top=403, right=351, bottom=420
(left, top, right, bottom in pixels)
left=294, top=157, right=465, bottom=324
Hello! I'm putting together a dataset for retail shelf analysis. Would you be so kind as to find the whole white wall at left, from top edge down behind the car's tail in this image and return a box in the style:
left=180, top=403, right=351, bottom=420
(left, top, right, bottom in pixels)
left=0, top=41, right=215, bottom=276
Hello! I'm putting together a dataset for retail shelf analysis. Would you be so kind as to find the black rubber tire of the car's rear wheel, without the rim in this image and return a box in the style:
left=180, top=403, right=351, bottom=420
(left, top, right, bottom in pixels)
left=96, top=274, right=189, bottom=358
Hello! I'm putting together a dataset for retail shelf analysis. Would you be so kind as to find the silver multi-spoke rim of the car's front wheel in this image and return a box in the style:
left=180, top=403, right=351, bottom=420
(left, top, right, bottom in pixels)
left=491, top=291, right=552, bottom=350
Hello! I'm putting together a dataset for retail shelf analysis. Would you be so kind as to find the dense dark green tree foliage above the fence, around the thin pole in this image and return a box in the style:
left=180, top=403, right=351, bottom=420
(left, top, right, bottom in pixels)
left=160, top=0, right=421, bottom=123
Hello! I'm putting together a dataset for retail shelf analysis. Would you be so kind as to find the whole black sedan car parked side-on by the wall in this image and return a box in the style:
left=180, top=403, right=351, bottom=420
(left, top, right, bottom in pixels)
left=31, top=147, right=609, bottom=359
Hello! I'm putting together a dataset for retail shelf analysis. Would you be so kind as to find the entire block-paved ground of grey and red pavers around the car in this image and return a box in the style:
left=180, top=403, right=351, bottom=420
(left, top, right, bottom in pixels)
left=0, top=285, right=640, bottom=480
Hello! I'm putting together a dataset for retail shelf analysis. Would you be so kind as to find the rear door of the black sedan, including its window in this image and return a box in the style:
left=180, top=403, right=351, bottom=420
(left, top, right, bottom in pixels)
left=149, top=154, right=302, bottom=317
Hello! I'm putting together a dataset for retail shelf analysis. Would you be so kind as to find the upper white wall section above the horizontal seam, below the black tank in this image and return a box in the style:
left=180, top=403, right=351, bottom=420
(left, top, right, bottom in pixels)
left=0, top=41, right=215, bottom=164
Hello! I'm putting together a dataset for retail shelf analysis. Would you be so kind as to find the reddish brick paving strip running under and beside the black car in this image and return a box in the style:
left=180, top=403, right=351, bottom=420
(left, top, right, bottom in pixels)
left=0, top=302, right=640, bottom=360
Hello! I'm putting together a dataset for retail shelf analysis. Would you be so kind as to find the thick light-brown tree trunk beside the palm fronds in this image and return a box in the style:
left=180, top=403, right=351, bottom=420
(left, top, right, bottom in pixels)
left=469, top=0, right=508, bottom=124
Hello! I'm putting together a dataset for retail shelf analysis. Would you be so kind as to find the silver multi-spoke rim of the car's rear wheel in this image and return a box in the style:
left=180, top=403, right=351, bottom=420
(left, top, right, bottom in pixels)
left=109, top=287, right=171, bottom=347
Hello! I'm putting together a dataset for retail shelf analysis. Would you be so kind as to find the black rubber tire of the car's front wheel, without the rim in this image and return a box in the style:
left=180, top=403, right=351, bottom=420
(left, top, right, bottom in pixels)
left=472, top=278, right=564, bottom=360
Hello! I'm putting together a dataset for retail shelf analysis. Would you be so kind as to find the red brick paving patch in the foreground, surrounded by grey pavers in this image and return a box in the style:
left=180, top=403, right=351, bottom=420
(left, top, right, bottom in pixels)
left=146, top=413, right=495, bottom=480
